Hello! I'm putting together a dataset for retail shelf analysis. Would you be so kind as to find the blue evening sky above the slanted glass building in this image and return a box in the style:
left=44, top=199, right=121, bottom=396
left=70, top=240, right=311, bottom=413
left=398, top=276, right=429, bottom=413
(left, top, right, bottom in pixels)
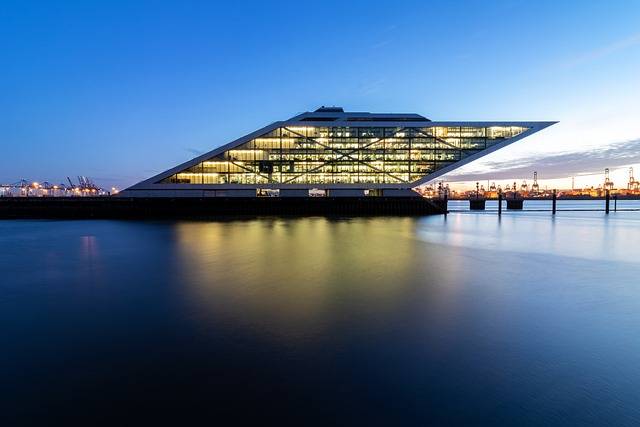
left=0, top=0, right=640, bottom=188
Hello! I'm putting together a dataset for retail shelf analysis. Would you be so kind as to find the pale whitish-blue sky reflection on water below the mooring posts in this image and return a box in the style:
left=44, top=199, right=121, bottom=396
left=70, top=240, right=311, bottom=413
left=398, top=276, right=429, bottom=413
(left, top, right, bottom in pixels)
left=416, top=212, right=640, bottom=263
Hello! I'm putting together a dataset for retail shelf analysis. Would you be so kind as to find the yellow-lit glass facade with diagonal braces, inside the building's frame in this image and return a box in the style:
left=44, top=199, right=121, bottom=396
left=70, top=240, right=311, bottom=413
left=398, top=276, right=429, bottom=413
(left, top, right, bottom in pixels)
left=160, top=126, right=528, bottom=185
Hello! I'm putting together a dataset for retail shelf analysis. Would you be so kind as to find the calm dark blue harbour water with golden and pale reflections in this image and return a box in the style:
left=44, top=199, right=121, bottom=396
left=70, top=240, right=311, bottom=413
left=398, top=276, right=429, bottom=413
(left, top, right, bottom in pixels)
left=0, top=206, right=640, bottom=425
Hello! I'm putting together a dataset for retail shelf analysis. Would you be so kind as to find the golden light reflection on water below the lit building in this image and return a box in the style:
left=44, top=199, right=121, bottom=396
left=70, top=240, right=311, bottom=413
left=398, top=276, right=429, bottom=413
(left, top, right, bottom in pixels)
left=176, top=218, right=436, bottom=338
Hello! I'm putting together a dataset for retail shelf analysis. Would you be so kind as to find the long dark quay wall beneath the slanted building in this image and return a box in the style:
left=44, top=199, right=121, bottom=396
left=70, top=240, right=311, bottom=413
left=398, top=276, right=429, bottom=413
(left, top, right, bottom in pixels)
left=0, top=197, right=446, bottom=219
